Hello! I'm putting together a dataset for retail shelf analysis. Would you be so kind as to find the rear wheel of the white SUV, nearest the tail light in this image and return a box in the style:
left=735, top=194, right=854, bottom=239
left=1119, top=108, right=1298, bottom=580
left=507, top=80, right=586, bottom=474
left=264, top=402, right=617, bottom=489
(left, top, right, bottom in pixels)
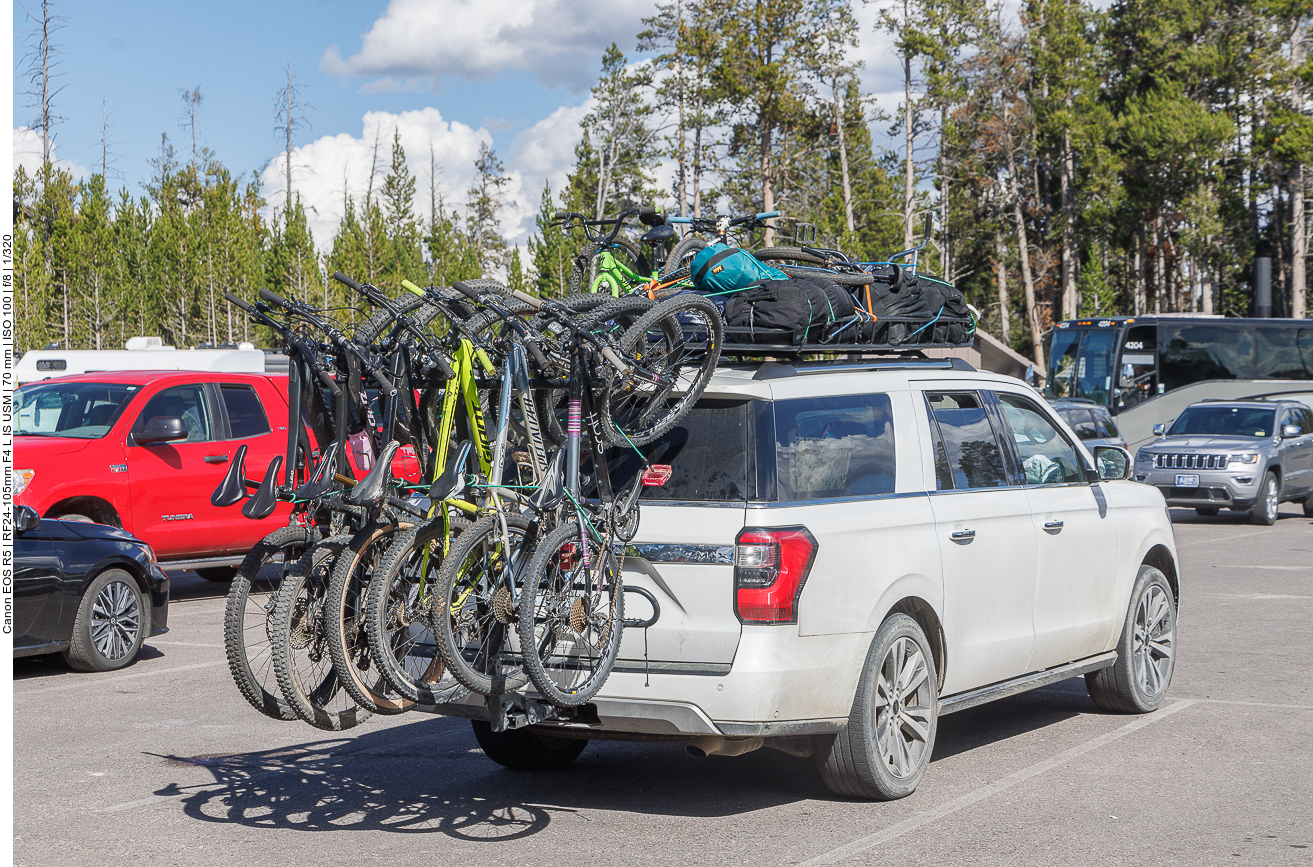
left=815, top=613, right=939, bottom=801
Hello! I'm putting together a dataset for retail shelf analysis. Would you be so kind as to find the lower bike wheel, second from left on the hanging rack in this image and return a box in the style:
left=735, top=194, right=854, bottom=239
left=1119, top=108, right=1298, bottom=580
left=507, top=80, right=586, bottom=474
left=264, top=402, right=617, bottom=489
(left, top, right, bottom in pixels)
left=270, top=535, right=372, bottom=732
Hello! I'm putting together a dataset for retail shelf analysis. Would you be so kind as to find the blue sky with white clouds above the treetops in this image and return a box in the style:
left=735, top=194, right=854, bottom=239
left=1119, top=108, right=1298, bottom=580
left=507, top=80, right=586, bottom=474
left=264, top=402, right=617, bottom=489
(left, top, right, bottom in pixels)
left=13, top=0, right=901, bottom=242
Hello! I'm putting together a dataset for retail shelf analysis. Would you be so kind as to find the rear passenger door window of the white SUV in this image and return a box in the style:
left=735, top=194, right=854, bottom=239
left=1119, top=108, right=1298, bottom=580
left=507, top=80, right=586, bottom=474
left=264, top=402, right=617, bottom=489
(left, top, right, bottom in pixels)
left=926, top=391, right=1007, bottom=490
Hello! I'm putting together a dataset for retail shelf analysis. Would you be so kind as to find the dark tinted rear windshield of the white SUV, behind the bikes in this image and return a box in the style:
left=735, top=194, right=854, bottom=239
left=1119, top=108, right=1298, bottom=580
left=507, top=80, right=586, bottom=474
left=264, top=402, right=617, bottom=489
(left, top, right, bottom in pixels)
left=608, top=401, right=748, bottom=502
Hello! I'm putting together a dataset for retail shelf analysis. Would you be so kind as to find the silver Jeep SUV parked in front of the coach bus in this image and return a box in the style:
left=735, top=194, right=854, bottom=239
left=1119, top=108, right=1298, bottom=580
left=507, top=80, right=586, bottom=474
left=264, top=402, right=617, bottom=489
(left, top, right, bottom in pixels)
left=1136, top=401, right=1313, bottom=524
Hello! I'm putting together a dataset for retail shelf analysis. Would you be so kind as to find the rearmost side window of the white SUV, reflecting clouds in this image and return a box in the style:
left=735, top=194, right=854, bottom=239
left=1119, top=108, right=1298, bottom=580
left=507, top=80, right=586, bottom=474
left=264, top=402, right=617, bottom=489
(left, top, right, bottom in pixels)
left=775, top=394, right=894, bottom=502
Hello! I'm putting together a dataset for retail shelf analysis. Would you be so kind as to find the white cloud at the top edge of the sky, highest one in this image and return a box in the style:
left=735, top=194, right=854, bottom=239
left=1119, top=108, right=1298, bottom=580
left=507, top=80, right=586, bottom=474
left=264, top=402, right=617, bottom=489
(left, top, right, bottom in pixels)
left=320, top=0, right=654, bottom=93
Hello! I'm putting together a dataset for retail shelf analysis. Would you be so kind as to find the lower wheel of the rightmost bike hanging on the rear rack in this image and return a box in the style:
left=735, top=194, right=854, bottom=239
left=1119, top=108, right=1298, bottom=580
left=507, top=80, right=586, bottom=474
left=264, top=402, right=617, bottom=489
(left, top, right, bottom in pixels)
left=519, top=519, right=625, bottom=708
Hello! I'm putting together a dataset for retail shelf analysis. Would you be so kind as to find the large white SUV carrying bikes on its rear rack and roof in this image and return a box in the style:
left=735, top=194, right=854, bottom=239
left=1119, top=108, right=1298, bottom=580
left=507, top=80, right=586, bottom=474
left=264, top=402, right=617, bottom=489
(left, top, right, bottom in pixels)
left=437, top=360, right=1179, bottom=799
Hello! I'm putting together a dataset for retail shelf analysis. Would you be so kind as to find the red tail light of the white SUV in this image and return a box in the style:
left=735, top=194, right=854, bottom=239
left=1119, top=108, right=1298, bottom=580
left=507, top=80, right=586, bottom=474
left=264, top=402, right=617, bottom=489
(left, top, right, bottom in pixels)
left=734, top=527, right=817, bottom=623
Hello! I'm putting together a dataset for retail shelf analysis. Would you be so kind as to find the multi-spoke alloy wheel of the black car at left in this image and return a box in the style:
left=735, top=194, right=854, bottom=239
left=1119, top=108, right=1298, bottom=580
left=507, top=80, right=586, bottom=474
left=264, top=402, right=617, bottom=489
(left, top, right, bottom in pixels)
left=64, top=569, right=150, bottom=671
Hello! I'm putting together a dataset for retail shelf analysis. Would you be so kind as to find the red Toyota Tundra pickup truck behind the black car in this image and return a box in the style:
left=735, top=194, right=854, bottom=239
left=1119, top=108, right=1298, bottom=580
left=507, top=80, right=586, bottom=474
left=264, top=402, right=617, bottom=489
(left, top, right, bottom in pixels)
left=13, top=370, right=300, bottom=581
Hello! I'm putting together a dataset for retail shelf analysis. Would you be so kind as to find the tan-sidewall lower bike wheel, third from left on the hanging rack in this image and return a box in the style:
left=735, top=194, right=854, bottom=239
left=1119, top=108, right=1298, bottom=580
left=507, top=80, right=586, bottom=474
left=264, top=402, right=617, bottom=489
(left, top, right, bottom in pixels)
left=324, top=520, right=415, bottom=716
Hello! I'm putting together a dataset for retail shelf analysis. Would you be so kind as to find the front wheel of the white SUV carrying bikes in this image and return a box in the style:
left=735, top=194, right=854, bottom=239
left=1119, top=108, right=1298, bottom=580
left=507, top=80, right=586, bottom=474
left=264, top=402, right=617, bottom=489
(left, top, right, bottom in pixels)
left=1085, top=565, right=1176, bottom=713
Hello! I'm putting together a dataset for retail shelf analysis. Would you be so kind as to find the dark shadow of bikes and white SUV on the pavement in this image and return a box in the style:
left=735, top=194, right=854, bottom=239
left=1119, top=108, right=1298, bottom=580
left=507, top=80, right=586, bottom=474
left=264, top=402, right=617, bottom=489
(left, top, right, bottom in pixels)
left=155, top=720, right=832, bottom=842
